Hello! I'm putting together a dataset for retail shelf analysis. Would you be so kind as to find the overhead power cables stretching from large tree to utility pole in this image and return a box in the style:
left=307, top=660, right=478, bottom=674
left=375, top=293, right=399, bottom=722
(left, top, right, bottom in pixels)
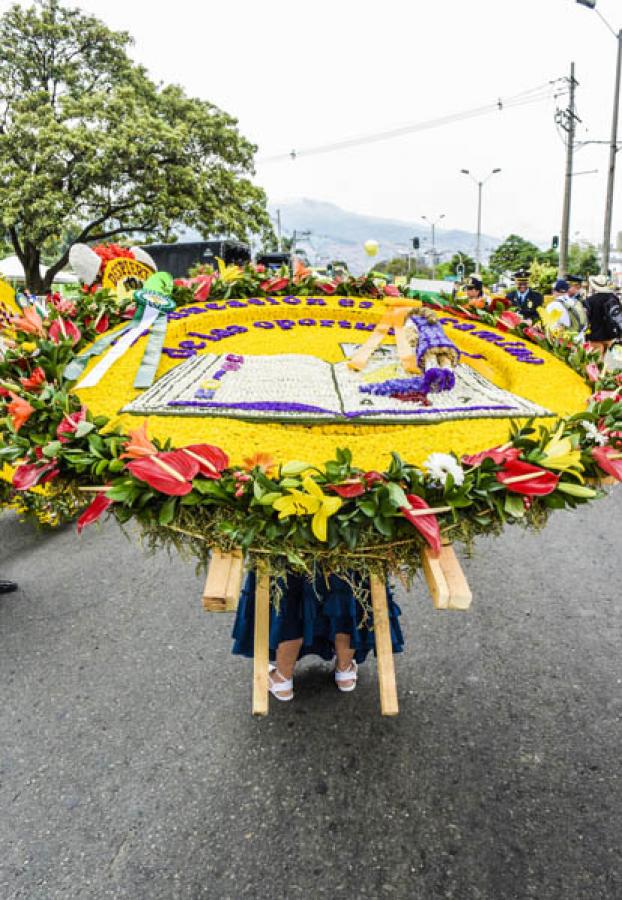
left=256, top=78, right=566, bottom=164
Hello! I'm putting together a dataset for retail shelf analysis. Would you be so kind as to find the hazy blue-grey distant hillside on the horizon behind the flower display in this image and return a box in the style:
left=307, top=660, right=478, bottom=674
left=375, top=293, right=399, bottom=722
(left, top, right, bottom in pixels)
left=269, top=198, right=501, bottom=272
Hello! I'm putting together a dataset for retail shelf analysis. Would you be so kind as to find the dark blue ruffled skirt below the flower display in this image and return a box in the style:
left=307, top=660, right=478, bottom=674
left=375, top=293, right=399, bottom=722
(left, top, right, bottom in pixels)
left=232, top=572, right=404, bottom=663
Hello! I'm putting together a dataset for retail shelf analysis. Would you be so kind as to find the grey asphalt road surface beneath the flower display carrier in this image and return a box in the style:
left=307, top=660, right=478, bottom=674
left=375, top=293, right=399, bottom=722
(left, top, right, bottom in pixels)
left=0, top=490, right=622, bottom=900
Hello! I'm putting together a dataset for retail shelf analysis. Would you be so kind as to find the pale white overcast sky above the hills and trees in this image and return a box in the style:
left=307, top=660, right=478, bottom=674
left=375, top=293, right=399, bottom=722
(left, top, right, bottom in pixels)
left=0, top=0, right=622, bottom=241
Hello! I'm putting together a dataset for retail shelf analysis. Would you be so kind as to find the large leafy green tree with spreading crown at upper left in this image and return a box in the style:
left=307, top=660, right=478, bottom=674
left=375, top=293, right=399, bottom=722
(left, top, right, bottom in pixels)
left=0, top=0, right=271, bottom=293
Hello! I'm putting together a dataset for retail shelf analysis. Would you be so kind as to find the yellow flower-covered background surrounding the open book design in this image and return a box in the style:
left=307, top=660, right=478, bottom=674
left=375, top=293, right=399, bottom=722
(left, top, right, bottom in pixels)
left=78, top=297, right=591, bottom=469
